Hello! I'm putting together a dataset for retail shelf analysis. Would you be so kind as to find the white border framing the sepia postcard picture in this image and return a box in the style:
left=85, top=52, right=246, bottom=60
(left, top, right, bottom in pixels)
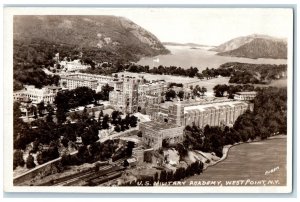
left=3, top=6, right=295, bottom=193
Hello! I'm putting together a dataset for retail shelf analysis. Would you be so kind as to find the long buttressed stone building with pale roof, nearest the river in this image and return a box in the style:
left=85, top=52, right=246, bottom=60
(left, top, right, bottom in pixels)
left=147, top=99, right=249, bottom=127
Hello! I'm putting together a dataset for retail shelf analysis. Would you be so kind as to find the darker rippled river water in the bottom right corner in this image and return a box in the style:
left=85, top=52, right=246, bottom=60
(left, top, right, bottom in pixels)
left=186, top=137, right=287, bottom=186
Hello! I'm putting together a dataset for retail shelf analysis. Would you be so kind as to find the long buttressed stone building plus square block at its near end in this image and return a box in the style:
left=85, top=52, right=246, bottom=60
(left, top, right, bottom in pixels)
left=139, top=99, right=249, bottom=149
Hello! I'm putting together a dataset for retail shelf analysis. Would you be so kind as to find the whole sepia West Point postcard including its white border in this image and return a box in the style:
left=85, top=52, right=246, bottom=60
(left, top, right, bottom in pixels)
left=4, top=7, right=295, bottom=193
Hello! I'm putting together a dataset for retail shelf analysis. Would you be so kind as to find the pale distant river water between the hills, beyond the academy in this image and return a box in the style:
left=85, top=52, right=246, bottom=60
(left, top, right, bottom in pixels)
left=137, top=46, right=287, bottom=71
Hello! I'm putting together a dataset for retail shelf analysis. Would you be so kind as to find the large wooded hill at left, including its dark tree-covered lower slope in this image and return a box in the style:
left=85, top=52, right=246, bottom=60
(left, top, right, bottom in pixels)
left=13, top=15, right=169, bottom=90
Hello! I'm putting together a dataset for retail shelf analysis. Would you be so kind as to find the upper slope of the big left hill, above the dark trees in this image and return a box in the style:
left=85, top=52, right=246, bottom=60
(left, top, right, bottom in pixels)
left=14, top=16, right=168, bottom=62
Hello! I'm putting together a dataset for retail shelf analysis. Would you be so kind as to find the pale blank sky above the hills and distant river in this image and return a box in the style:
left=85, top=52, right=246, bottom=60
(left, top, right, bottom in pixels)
left=98, top=8, right=293, bottom=45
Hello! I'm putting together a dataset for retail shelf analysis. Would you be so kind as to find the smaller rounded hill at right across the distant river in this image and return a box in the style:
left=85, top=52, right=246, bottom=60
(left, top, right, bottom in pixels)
left=212, top=35, right=287, bottom=59
